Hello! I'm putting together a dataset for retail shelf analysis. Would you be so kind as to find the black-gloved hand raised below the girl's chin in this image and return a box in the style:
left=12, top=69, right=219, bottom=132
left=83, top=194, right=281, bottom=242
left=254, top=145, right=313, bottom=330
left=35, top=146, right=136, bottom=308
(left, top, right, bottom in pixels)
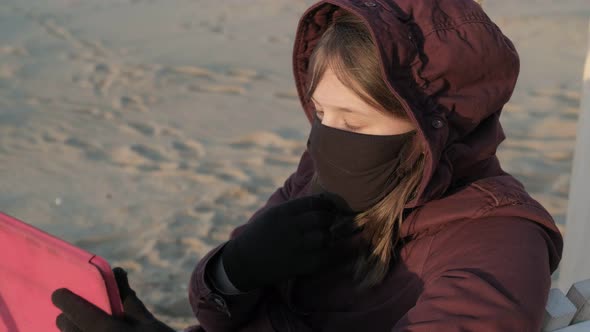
left=221, top=194, right=360, bottom=292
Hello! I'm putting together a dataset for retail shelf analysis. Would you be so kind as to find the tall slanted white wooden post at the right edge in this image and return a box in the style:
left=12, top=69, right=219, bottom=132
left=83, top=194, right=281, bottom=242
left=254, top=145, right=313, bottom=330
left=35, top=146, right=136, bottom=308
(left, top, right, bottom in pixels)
left=558, top=19, right=590, bottom=292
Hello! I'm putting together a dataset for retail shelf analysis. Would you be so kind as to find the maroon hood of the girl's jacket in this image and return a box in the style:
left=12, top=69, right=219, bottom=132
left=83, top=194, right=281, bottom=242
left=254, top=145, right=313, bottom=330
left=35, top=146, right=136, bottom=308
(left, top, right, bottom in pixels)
left=293, top=0, right=563, bottom=269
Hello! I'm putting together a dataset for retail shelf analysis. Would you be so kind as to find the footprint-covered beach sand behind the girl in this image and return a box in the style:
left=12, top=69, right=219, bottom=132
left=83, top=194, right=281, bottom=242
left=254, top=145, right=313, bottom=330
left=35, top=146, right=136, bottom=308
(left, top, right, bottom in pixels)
left=0, top=0, right=590, bottom=329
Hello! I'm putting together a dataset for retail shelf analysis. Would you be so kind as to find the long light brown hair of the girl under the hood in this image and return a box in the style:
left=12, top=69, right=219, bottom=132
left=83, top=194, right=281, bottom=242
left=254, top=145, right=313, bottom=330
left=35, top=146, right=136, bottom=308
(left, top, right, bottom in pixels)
left=306, top=9, right=424, bottom=290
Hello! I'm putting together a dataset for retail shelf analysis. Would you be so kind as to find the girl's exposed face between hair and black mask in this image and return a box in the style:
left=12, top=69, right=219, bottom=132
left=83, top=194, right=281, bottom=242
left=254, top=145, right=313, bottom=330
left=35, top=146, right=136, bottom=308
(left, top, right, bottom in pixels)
left=312, top=68, right=415, bottom=135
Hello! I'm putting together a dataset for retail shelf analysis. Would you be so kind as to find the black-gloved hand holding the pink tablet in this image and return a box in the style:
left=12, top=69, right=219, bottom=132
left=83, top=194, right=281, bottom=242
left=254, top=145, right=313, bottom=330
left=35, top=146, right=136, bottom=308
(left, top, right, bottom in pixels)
left=51, top=267, right=174, bottom=332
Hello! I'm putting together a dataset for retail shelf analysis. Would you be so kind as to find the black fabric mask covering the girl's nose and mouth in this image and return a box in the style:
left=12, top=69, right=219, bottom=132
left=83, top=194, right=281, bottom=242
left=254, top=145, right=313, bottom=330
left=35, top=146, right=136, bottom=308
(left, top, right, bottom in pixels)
left=307, top=116, right=416, bottom=212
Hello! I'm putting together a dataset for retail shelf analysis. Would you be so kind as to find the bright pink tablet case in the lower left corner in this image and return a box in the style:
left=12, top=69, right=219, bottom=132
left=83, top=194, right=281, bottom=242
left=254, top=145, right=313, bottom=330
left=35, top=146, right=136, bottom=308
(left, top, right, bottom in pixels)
left=0, top=213, right=123, bottom=332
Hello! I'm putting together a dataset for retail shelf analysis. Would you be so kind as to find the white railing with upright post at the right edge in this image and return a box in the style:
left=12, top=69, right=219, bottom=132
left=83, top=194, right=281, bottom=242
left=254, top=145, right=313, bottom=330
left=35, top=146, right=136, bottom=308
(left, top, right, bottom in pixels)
left=543, top=17, right=590, bottom=332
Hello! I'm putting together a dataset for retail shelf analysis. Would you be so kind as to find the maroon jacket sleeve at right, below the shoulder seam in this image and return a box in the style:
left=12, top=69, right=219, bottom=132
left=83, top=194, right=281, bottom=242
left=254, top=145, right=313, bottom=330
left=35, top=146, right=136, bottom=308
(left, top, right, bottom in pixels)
left=392, top=217, right=561, bottom=332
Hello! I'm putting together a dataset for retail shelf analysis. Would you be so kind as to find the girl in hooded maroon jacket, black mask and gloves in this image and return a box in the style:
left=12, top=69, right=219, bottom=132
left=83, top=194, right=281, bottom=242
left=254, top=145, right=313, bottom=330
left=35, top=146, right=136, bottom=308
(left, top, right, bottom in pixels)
left=53, top=0, right=563, bottom=332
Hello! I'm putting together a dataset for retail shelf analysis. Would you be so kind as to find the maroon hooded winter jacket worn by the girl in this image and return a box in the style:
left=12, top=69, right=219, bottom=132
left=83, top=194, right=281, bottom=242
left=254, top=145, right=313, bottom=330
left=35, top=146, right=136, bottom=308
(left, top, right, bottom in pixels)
left=189, top=0, right=563, bottom=332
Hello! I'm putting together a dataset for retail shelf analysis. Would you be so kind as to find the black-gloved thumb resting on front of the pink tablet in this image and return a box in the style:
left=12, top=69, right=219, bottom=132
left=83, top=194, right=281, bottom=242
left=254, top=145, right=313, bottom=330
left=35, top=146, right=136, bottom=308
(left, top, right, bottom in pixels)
left=51, top=288, right=115, bottom=332
